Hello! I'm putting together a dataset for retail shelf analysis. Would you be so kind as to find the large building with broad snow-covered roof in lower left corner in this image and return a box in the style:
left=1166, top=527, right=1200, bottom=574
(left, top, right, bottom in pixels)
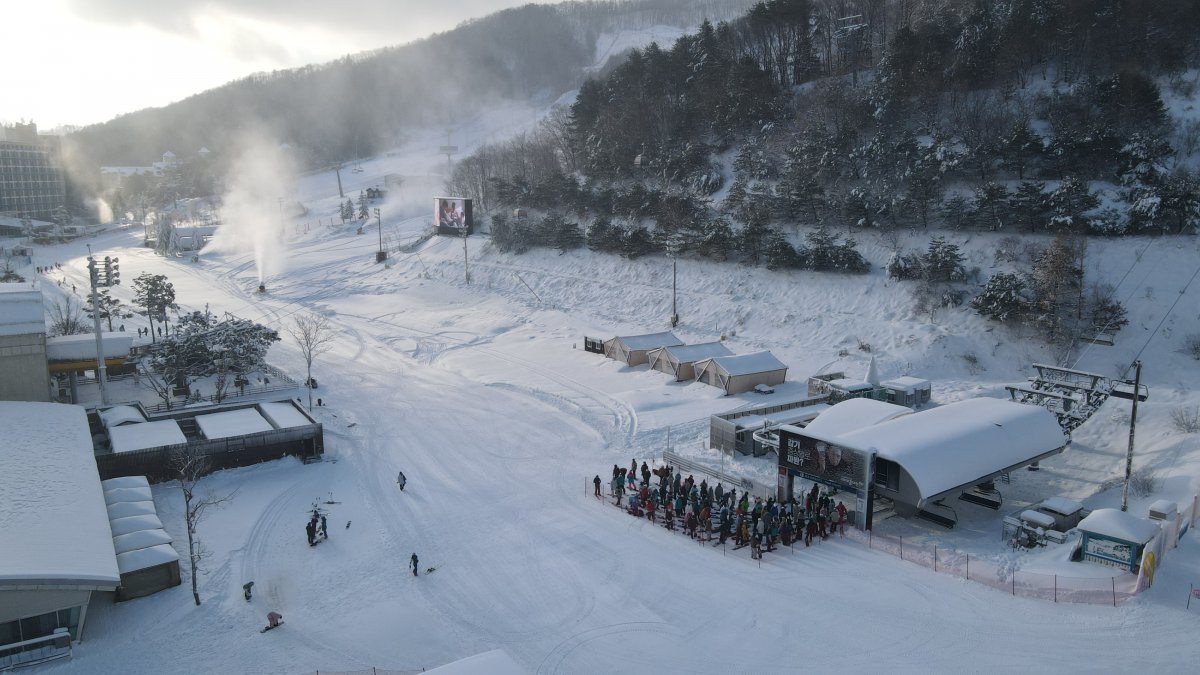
left=0, top=401, right=120, bottom=670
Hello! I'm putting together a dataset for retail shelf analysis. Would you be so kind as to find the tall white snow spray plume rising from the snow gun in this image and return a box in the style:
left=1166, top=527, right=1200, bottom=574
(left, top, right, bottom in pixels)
left=212, top=135, right=295, bottom=283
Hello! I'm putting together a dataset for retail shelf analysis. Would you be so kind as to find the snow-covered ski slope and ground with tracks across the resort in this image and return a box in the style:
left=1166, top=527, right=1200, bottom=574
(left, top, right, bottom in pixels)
left=9, top=110, right=1200, bottom=674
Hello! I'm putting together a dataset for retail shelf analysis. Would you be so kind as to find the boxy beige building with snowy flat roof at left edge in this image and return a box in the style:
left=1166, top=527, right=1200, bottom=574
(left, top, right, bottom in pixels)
left=0, top=283, right=50, bottom=402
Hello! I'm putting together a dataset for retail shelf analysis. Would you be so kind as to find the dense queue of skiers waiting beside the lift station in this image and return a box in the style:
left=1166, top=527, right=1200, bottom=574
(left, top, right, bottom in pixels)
left=592, top=459, right=846, bottom=558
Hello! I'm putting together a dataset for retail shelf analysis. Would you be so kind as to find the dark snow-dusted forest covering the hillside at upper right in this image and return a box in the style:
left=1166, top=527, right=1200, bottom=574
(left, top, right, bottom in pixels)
left=451, top=0, right=1200, bottom=355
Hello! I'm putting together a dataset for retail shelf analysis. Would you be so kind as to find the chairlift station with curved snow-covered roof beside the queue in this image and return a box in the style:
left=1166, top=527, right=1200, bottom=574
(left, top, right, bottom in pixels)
left=780, top=399, right=1070, bottom=527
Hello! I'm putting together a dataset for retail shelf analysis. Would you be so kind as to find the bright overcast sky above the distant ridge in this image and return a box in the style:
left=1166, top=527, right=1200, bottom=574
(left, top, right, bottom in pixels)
left=0, top=0, right=544, bottom=131
